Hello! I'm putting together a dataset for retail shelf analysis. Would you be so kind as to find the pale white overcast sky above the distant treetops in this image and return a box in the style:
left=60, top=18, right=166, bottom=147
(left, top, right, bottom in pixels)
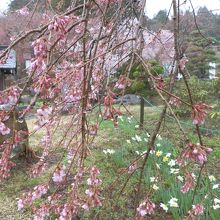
left=0, top=0, right=220, bottom=18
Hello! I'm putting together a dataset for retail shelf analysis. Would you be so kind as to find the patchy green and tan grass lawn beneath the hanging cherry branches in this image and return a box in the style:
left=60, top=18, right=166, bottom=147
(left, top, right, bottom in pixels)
left=0, top=106, right=220, bottom=220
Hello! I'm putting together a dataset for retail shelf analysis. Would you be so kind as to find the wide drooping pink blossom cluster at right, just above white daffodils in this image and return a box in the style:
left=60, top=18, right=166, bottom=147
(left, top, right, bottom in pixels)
left=177, top=143, right=212, bottom=165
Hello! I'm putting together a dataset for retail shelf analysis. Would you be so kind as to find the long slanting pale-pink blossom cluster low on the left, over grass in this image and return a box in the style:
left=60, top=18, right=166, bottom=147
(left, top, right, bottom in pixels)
left=17, top=184, right=49, bottom=210
